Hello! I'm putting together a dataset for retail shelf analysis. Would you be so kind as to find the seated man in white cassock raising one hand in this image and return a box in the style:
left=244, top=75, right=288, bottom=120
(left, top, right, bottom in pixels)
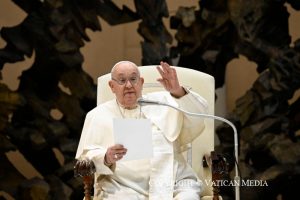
left=76, top=61, right=207, bottom=200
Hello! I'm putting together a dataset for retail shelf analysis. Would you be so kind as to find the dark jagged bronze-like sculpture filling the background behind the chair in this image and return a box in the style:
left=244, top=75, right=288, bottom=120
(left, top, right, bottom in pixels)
left=0, top=0, right=300, bottom=199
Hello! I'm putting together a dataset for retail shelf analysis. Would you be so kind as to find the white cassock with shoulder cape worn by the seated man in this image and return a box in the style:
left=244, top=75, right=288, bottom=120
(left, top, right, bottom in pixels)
left=76, top=91, right=207, bottom=200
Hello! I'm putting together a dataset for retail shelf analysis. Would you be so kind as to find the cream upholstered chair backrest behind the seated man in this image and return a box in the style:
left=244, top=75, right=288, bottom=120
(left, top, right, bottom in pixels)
left=97, top=65, right=215, bottom=196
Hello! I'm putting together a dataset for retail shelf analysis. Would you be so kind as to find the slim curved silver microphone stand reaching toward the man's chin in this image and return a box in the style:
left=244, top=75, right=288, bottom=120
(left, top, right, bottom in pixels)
left=138, top=98, right=240, bottom=200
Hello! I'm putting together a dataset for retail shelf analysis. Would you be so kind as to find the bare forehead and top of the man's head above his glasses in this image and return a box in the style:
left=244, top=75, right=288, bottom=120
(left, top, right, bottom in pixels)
left=111, top=61, right=140, bottom=76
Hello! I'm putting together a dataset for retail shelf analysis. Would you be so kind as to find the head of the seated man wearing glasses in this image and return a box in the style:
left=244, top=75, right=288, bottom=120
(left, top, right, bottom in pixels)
left=109, top=62, right=144, bottom=108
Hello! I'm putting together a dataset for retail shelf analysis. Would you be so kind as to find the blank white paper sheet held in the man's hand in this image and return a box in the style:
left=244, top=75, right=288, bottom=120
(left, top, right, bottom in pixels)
left=113, top=118, right=153, bottom=161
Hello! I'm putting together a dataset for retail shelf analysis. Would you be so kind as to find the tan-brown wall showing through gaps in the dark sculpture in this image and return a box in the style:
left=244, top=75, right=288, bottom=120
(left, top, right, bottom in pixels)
left=0, top=0, right=300, bottom=199
